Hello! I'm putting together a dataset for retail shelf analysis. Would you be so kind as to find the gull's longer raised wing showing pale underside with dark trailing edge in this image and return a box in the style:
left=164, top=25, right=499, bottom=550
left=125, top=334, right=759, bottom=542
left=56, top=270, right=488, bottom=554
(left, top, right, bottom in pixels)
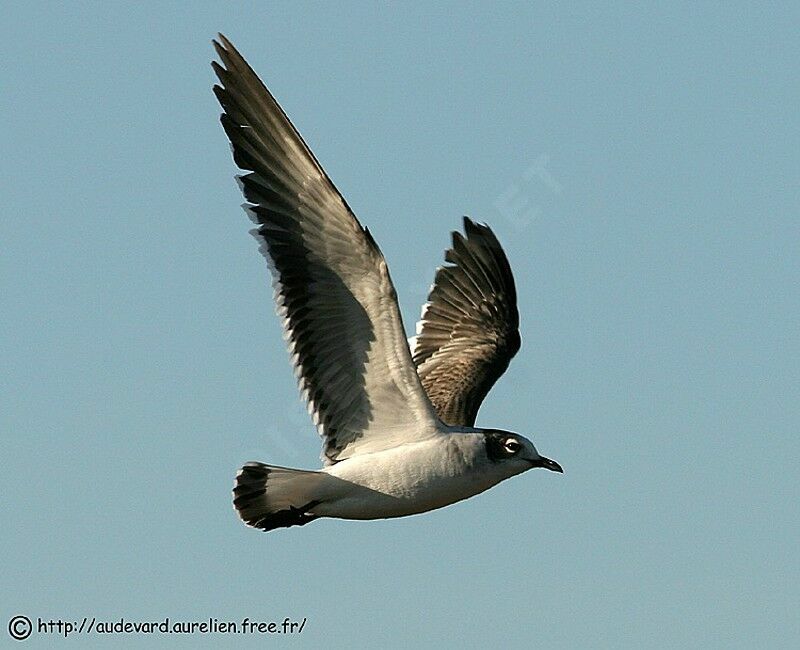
left=212, top=35, right=438, bottom=463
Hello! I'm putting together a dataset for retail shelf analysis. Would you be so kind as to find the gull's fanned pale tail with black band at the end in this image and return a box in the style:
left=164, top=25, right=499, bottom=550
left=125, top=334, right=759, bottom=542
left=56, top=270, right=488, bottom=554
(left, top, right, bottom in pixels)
left=233, top=463, right=324, bottom=531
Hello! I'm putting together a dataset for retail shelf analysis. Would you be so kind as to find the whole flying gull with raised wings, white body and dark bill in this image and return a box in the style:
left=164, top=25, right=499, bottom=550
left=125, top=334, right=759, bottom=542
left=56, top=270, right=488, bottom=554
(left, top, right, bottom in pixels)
left=212, top=34, right=563, bottom=531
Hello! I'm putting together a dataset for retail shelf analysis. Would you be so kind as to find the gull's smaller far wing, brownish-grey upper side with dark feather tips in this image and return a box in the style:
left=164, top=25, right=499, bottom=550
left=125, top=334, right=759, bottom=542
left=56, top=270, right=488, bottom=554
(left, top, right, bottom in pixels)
left=412, top=217, right=520, bottom=426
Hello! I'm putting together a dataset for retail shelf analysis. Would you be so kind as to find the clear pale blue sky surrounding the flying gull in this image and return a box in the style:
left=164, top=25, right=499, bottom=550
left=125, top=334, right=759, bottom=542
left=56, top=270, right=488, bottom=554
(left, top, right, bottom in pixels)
left=0, top=1, right=800, bottom=648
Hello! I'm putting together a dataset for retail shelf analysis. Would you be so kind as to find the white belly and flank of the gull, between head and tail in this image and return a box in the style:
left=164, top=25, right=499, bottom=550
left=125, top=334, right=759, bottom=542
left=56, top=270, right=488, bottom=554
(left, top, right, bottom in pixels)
left=312, top=435, right=505, bottom=519
